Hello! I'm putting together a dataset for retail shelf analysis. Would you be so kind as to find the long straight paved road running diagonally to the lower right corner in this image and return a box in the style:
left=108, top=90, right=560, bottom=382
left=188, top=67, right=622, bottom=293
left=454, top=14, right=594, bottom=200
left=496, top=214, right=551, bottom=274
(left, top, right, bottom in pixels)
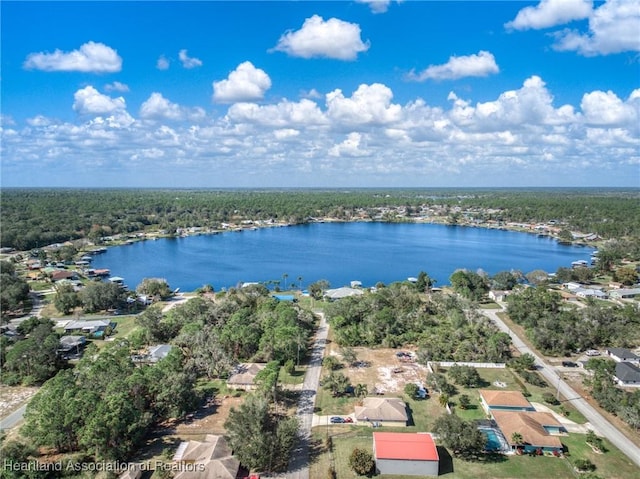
left=482, top=310, right=640, bottom=466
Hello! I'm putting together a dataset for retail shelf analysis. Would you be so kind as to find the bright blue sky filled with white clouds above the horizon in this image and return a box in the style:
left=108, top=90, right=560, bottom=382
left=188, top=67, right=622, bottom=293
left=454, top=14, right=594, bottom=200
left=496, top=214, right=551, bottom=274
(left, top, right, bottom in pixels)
left=0, top=0, right=640, bottom=188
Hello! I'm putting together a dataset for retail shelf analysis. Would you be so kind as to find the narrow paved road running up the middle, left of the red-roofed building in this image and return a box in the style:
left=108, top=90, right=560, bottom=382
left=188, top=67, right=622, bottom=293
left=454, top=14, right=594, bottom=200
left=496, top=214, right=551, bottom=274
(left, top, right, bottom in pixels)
left=277, top=311, right=329, bottom=479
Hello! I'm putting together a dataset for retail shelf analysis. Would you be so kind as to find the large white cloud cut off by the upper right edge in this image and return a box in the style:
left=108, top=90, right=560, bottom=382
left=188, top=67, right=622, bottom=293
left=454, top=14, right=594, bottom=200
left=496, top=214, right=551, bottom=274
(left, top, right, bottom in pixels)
left=554, top=0, right=640, bottom=56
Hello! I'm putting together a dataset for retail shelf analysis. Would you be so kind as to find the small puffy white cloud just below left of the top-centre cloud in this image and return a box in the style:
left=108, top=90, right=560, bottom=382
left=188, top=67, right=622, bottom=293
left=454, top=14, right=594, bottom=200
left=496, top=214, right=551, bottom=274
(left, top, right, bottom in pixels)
left=213, top=61, right=271, bottom=103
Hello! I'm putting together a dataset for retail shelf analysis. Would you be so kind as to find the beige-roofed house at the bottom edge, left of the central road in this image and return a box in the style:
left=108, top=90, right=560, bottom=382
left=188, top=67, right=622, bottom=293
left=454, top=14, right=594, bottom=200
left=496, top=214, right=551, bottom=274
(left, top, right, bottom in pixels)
left=172, top=434, right=240, bottom=479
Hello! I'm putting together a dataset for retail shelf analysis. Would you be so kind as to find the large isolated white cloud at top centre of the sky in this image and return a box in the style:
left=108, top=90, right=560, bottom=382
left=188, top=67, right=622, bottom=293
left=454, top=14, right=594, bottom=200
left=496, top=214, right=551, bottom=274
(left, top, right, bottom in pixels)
left=274, top=15, right=369, bottom=60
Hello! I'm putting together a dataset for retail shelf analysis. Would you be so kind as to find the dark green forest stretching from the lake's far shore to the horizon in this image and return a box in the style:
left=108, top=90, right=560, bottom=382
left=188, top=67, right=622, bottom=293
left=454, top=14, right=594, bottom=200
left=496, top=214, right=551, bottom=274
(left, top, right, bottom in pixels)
left=0, top=188, right=640, bottom=251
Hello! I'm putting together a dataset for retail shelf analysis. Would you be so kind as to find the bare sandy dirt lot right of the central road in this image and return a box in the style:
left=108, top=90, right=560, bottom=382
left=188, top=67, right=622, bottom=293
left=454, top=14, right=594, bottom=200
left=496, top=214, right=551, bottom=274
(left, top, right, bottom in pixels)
left=330, top=348, right=427, bottom=394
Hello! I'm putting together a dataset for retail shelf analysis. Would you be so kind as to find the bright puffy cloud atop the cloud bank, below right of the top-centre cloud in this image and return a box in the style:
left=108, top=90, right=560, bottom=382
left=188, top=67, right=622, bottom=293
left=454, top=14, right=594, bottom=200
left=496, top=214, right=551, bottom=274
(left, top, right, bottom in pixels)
left=326, top=83, right=402, bottom=125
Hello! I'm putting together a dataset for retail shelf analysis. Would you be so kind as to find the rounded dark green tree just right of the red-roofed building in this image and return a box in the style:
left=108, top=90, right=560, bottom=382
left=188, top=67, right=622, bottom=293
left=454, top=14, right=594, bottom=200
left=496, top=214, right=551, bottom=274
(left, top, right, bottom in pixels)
left=433, top=414, right=487, bottom=459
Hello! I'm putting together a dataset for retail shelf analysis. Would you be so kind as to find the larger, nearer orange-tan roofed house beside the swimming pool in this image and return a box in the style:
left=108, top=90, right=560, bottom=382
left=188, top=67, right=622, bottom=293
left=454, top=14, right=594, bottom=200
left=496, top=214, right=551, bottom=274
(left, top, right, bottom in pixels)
left=492, top=411, right=566, bottom=453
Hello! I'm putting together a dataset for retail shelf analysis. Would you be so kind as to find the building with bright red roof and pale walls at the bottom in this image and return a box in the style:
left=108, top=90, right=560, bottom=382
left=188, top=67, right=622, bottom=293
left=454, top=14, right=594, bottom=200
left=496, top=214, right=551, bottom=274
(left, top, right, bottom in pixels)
left=373, top=432, right=440, bottom=476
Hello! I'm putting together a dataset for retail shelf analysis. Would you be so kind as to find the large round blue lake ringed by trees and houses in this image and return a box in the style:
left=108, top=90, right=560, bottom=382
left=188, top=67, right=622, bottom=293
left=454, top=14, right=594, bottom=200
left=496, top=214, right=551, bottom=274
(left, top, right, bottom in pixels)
left=92, top=223, right=593, bottom=291
